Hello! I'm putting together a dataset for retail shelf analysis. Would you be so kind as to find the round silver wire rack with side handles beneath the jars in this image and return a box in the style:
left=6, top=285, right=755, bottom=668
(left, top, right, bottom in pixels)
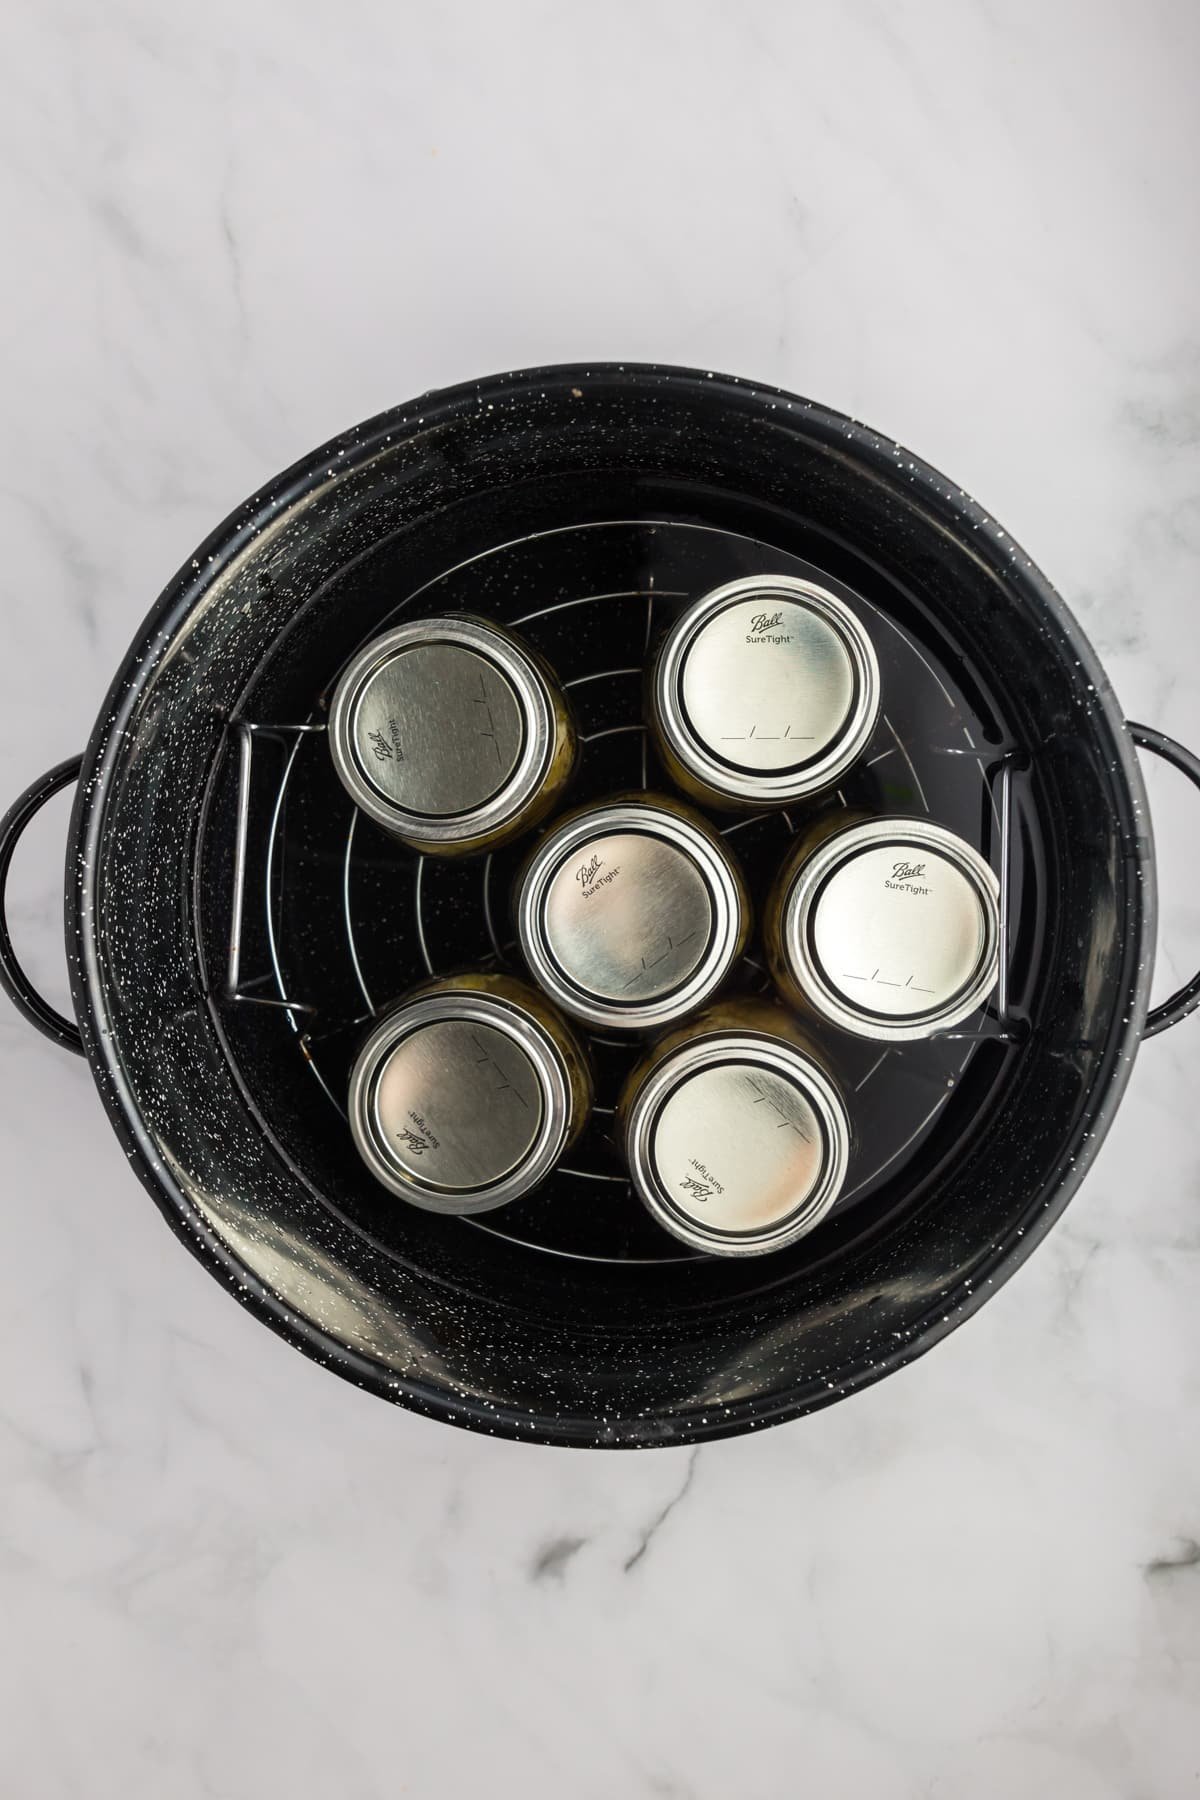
left=213, top=522, right=1027, bottom=1262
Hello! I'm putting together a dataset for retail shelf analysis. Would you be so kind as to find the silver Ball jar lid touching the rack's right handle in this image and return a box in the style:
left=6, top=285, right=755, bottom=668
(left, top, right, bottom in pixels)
left=779, top=819, right=1000, bottom=1042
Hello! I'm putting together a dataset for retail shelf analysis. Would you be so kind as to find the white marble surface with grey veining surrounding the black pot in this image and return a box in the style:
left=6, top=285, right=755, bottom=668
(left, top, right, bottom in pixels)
left=0, top=0, right=1200, bottom=1800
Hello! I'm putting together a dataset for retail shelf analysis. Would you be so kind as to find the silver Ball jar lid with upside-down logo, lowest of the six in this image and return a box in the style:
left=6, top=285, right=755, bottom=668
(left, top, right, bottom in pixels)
left=624, top=1031, right=849, bottom=1256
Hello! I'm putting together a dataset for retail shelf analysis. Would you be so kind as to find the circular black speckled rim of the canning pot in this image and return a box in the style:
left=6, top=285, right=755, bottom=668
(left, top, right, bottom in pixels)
left=65, top=362, right=1157, bottom=1449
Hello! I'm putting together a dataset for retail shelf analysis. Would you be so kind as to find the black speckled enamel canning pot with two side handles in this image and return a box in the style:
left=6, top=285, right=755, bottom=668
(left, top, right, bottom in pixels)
left=0, top=365, right=1200, bottom=1445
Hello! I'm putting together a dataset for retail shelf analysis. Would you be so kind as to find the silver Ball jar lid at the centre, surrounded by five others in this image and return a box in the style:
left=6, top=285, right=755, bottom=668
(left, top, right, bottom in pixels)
left=516, top=796, right=748, bottom=1030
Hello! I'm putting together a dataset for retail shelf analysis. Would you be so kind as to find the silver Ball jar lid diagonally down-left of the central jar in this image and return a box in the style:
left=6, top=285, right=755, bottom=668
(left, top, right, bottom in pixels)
left=349, top=990, right=572, bottom=1213
